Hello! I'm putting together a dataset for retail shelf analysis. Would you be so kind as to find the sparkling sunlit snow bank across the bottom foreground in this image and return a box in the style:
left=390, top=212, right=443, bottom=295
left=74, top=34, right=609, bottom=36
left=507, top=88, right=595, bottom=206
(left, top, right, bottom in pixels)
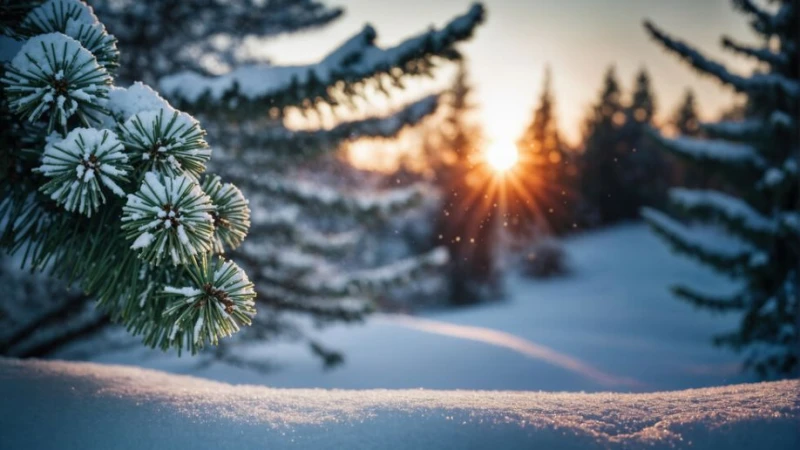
left=0, top=359, right=800, bottom=450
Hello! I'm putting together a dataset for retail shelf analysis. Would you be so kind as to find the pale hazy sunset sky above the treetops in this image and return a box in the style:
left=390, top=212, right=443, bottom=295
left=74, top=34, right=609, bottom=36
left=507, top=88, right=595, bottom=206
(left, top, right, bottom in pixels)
left=265, top=0, right=755, bottom=143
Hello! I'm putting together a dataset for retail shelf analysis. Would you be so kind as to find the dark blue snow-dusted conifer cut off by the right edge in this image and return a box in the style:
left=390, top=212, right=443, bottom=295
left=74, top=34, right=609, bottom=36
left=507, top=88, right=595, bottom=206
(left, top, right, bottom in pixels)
left=644, top=0, right=800, bottom=377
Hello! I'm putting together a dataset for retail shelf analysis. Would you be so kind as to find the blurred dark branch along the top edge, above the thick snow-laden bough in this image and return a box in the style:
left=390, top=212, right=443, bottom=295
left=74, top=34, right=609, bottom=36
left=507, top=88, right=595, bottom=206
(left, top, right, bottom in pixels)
left=92, top=0, right=344, bottom=85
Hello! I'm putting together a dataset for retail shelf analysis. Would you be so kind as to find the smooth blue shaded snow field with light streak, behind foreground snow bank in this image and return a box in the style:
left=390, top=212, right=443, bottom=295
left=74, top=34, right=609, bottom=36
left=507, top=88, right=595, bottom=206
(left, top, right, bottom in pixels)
left=90, top=224, right=753, bottom=392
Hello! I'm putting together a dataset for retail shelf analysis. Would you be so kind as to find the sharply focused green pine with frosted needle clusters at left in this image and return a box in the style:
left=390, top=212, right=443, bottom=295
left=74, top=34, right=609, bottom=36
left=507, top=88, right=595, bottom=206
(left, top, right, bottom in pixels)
left=0, top=0, right=255, bottom=353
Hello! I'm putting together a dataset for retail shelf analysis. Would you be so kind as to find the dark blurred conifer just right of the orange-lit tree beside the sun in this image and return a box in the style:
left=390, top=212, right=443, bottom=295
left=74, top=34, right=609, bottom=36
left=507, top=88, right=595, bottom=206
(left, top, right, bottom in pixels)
left=579, top=67, right=625, bottom=227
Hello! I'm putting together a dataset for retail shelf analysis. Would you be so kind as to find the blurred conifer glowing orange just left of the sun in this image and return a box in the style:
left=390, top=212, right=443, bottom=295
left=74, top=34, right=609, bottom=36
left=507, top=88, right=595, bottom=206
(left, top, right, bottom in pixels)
left=431, top=64, right=499, bottom=305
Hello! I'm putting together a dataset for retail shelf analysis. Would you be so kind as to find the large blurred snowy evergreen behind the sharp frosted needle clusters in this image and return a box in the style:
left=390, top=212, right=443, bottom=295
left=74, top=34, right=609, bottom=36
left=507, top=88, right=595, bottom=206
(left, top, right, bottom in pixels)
left=1, top=0, right=483, bottom=365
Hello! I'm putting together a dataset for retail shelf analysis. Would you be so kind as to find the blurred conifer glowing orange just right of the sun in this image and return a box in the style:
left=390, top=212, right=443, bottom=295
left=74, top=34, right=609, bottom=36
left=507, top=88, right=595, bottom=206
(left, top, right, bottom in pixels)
left=506, top=68, right=577, bottom=239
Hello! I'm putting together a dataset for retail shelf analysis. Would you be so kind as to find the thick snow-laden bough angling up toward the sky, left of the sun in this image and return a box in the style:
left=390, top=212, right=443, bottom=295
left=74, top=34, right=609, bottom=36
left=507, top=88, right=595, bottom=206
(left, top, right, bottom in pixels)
left=159, top=4, right=484, bottom=111
